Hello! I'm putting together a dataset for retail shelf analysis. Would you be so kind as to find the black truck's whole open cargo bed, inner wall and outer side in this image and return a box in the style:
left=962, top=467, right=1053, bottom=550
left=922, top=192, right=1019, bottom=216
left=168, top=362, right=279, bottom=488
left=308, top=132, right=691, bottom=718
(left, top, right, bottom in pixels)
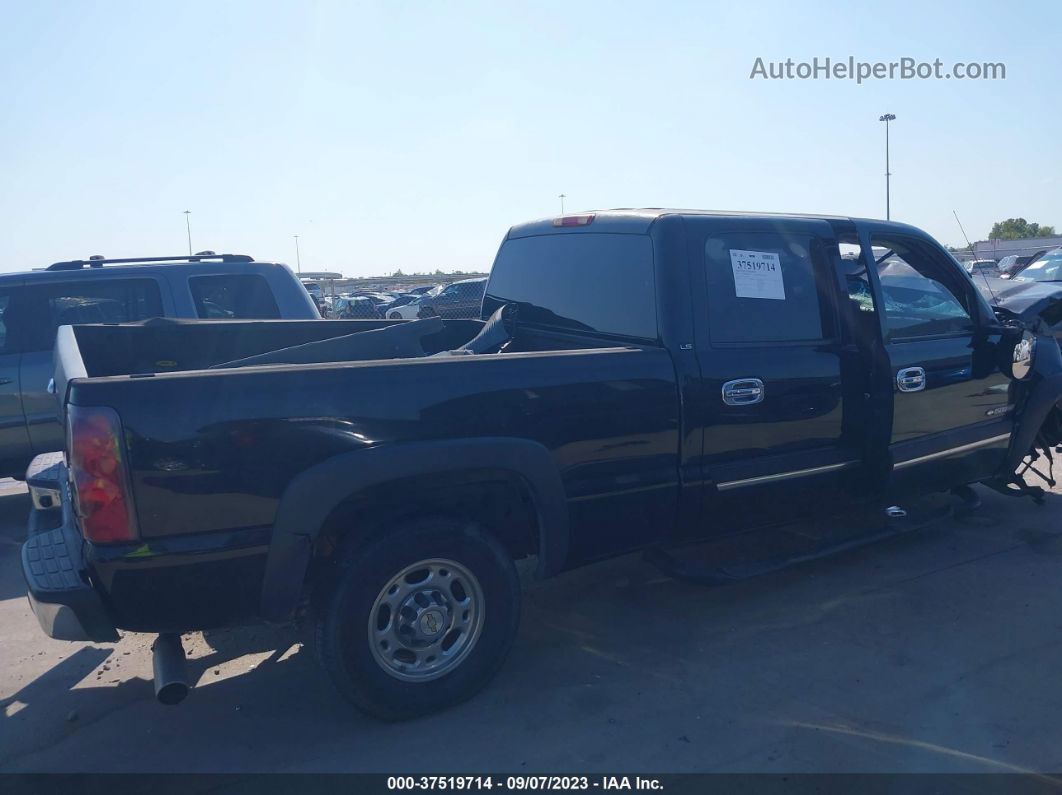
left=56, top=321, right=679, bottom=538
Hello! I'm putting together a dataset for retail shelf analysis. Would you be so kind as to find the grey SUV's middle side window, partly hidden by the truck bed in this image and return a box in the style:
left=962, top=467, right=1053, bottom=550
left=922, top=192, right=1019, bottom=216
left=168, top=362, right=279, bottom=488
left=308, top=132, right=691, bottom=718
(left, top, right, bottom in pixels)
left=18, top=279, right=162, bottom=351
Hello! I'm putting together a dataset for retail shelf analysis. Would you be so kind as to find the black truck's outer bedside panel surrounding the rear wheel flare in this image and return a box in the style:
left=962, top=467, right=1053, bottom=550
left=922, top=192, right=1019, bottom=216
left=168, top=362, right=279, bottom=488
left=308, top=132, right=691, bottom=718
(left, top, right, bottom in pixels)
left=71, top=347, right=680, bottom=560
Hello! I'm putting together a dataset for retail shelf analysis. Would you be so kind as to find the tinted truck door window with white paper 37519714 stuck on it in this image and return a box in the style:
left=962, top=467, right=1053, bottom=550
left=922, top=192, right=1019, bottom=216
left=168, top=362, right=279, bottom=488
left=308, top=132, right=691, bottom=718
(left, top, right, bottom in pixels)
left=704, top=231, right=835, bottom=344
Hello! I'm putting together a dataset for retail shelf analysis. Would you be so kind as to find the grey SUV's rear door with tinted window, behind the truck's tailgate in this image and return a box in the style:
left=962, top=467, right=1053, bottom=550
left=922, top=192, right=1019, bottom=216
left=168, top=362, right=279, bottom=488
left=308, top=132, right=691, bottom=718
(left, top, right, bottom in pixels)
left=19, top=272, right=165, bottom=454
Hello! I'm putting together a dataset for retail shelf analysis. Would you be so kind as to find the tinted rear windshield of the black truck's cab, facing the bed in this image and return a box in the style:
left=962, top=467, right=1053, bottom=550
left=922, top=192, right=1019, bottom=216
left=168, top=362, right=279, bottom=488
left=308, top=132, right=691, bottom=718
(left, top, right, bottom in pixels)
left=483, top=234, right=656, bottom=340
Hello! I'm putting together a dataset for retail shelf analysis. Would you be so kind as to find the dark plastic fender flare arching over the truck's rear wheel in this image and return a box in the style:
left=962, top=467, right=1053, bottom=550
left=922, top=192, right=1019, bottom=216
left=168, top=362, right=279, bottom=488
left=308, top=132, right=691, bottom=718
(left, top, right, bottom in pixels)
left=261, top=437, right=569, bottom=621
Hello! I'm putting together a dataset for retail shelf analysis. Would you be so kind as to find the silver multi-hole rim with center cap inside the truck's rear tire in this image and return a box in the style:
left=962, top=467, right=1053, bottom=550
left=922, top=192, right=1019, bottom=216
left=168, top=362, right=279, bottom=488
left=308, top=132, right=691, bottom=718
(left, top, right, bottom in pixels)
left=369, top=558, right=484, bottom=681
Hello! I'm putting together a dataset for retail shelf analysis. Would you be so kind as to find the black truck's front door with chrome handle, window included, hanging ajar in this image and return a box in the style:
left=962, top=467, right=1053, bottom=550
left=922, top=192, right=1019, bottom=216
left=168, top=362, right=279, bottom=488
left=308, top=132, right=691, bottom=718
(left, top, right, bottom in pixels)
left=864, top=227, right=1012, bottom=492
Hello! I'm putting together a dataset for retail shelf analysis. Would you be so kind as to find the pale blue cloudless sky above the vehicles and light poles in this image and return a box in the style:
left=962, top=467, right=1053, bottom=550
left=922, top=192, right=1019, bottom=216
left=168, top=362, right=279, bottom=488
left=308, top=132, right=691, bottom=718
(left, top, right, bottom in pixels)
left=0, top=0, right=1062, bottom=275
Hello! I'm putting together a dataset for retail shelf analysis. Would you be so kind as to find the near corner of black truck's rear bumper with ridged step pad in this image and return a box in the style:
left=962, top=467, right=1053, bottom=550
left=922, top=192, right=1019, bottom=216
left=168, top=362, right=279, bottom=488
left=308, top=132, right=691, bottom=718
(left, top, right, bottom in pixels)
left=22, top=520, right=118, bottom=643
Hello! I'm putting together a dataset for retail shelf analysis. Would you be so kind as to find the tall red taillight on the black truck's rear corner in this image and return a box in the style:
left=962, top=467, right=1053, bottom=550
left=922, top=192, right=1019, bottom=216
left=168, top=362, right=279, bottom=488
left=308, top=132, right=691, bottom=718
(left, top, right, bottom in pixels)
left=67, top=405, right=137, bottom=543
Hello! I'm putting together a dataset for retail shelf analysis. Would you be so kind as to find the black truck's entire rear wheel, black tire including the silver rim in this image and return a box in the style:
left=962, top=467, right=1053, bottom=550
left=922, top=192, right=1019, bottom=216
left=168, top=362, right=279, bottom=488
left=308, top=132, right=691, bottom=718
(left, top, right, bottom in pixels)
left=313, top=517, right=520, bottom=721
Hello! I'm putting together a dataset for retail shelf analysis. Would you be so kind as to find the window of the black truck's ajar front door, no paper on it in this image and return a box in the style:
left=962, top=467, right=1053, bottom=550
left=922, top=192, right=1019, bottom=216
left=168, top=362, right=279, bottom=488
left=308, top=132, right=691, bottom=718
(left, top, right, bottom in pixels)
left=871, top=237, right=974, bottom=342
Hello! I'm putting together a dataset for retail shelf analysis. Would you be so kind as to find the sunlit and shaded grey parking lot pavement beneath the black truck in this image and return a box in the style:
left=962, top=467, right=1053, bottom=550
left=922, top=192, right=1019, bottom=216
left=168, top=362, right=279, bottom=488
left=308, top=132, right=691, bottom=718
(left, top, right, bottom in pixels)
left=0, top=479, right=1062, bottom=773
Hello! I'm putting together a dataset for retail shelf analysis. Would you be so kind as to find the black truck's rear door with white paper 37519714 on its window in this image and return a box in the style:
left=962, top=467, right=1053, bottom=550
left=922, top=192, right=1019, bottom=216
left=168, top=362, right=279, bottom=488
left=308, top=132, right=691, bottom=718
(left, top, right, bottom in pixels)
left=687, top=218, right=867, bottom=533
